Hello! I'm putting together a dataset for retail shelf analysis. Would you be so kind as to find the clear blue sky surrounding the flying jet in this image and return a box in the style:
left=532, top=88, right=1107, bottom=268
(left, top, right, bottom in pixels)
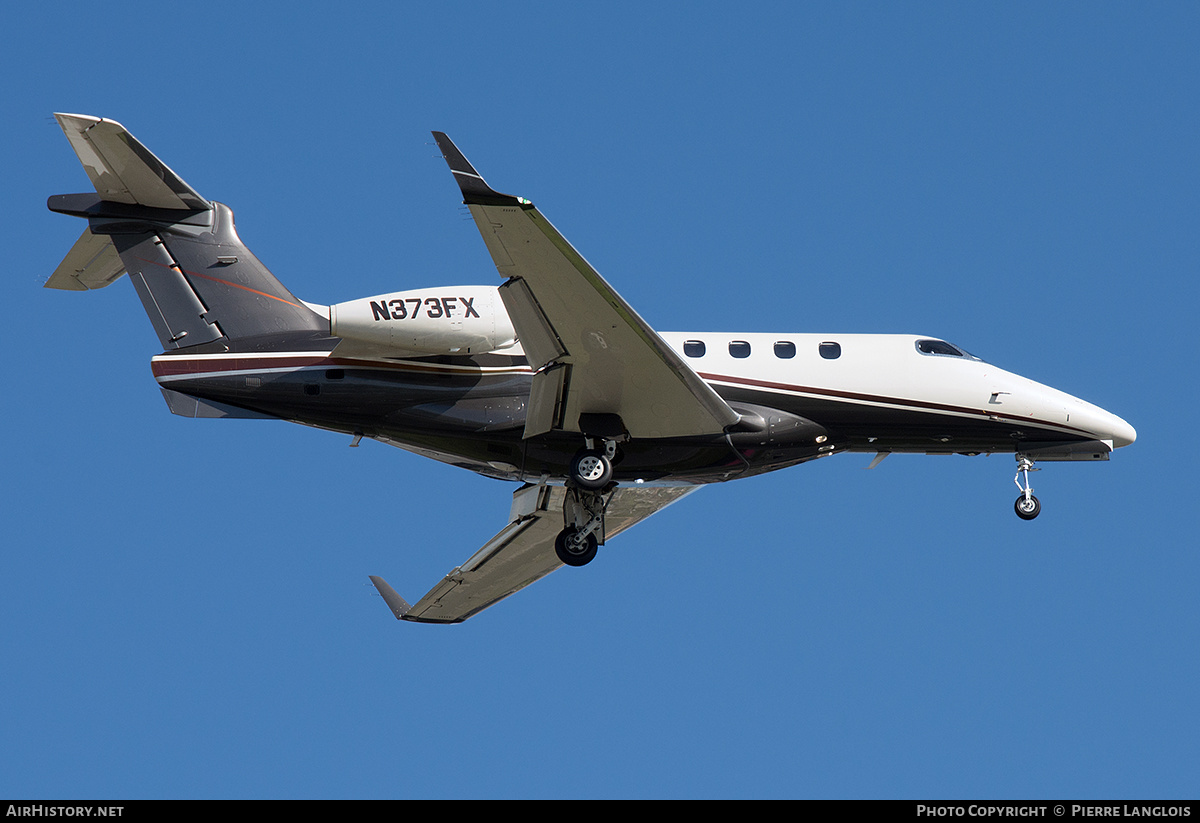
left=0, top=2, right=1200, bottom=798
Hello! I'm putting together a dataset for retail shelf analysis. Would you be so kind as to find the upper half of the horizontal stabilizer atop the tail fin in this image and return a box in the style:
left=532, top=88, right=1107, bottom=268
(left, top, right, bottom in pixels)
left=54, top=114, right=211, bottom=211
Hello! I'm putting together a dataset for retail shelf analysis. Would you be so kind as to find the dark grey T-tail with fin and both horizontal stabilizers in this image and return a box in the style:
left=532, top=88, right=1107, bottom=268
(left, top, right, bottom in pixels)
left=46, top=114, right=329, bottom=352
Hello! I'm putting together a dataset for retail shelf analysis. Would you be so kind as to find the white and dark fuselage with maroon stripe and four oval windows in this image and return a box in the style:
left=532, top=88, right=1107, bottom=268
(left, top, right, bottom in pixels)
left=152, top=332, right=1135, bottom=483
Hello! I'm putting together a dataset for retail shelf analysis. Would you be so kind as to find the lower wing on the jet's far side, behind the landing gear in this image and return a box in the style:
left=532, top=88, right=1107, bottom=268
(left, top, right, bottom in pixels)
left=371, top=483, right=700, bottom=623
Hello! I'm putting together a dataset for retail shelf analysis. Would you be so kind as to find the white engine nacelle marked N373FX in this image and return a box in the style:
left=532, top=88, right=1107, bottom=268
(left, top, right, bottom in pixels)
left=329, top=286, right=517, bottom=354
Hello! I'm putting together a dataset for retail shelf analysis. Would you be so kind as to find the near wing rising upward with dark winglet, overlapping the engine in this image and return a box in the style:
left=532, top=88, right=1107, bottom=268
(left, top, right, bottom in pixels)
left=433, top=132, right=739, bottom=439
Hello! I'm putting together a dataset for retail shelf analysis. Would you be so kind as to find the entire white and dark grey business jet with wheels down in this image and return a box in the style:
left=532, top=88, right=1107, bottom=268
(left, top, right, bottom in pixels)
left=46, top=114, right=1136, bottom=623
